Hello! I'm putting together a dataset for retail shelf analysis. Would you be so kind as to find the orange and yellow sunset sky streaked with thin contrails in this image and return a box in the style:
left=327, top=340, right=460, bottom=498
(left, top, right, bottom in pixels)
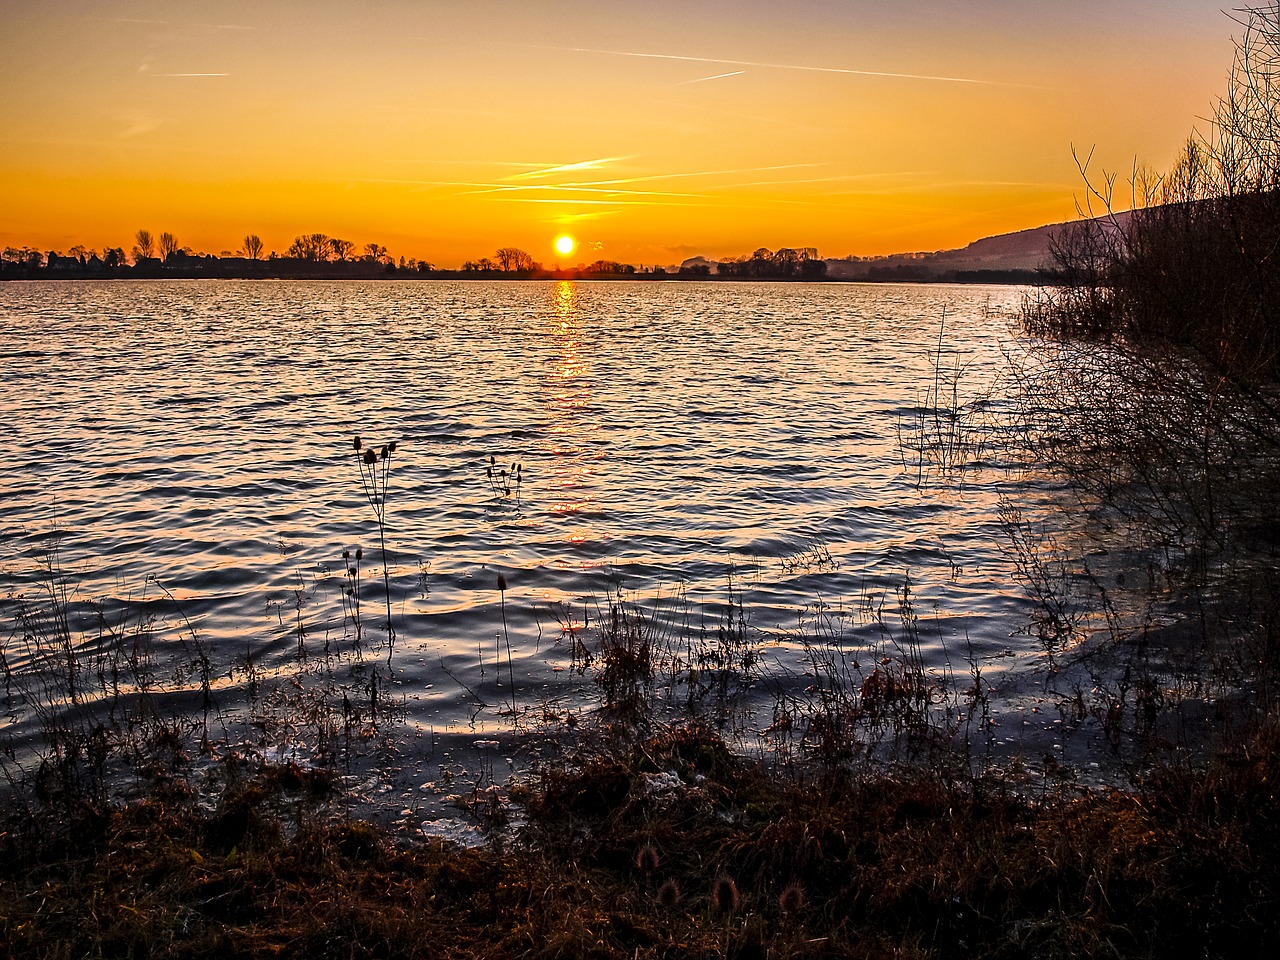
left=0, top=0, right=1236, bottom=268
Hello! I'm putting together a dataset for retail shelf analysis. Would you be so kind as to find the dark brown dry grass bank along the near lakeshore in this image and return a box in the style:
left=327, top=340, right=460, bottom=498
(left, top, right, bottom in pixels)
left=0, top=727, right=1280, bottom=957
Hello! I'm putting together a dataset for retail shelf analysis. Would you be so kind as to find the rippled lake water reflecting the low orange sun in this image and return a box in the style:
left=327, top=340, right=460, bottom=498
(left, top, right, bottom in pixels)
left=0, top=282, right=1059, bottom=814
